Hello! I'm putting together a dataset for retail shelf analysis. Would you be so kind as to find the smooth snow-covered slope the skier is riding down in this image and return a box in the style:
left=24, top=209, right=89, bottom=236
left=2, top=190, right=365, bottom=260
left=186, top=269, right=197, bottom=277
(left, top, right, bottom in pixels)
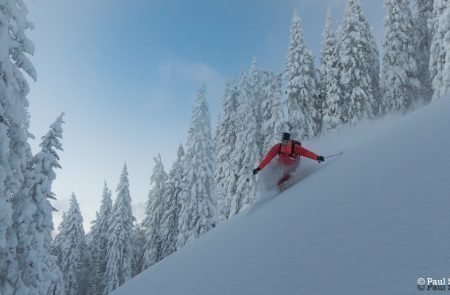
left=113, top=99, right=450, bottom=295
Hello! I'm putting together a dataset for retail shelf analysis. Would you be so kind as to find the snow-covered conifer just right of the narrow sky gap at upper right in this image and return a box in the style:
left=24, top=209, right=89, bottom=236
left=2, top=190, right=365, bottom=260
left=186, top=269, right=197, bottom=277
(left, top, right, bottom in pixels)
left=381, top=0, right=420, bottom=113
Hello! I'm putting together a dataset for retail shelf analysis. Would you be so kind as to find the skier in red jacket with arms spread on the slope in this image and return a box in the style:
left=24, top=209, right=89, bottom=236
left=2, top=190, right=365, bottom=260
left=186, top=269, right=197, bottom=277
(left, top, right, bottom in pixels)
left=253, top=132, right=325, bottom=188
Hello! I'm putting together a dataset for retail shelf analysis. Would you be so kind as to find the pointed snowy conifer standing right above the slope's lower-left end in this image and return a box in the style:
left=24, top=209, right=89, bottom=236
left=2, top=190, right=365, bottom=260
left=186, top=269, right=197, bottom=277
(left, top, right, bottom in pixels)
left=103, top=164, right=135, bottom=295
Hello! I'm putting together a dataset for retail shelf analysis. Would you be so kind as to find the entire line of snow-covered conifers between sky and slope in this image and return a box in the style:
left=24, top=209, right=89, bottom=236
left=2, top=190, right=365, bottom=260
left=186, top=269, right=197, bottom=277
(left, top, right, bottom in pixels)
left=0, top=0, right=450, bottom=295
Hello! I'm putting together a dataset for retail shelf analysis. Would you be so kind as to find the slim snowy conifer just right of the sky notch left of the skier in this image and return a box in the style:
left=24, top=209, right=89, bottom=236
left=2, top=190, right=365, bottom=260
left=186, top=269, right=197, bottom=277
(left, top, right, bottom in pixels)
left=214, top=80, right=240, bottom=221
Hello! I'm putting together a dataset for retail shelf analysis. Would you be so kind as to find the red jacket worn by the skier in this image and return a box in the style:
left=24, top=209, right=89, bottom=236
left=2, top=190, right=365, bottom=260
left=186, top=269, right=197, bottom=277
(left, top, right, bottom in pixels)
left=258, top=141, right=317, bottom=169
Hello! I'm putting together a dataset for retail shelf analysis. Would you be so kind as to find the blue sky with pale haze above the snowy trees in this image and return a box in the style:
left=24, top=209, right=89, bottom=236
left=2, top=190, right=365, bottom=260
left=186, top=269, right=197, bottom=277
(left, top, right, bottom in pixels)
left=27, top=0, right=384, bottom=230
